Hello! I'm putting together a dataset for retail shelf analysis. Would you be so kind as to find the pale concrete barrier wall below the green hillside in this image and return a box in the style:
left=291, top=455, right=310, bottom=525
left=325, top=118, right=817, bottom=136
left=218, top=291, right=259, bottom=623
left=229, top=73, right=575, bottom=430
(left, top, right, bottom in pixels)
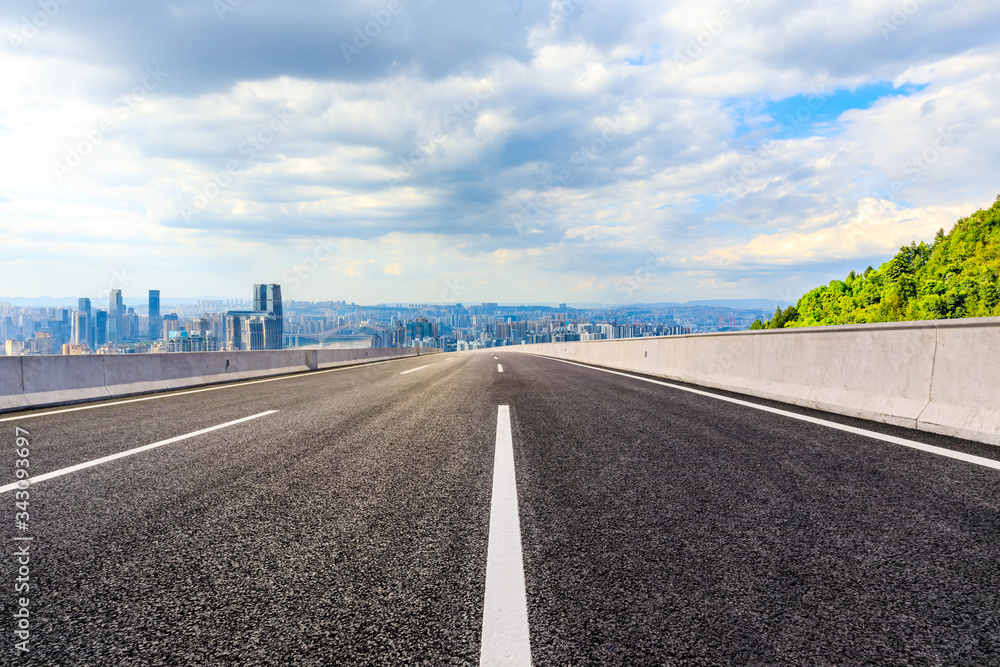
left=504, top=318, right=1000, bottom=445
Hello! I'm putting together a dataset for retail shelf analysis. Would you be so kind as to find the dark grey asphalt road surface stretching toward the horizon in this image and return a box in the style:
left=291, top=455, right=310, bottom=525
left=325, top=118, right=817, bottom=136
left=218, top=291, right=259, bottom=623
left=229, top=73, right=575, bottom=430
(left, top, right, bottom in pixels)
left=0, top=348, right=1000, bottom=666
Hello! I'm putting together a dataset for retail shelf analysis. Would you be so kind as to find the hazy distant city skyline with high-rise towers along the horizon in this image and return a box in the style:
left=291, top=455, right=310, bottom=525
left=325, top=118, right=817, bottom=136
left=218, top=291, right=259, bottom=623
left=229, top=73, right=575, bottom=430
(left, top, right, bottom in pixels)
left=0, top=284, right=769, bottom=355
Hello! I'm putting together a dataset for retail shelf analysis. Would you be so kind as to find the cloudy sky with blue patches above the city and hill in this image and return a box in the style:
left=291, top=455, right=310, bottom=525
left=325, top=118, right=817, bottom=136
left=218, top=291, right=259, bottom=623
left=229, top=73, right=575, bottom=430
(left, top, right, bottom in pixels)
left=0, top=0, right=1000, bottom=303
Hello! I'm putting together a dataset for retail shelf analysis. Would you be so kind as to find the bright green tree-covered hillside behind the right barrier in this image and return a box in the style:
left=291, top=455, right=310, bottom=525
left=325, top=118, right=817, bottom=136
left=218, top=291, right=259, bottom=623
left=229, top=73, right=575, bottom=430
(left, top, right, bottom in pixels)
left=750, top=196, right=1000, bottom=329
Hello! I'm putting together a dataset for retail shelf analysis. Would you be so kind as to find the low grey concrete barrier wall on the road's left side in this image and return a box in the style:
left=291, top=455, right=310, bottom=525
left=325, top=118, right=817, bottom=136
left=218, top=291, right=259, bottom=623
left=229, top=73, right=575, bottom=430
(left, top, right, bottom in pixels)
left=0, top=348, right=438, bottom=412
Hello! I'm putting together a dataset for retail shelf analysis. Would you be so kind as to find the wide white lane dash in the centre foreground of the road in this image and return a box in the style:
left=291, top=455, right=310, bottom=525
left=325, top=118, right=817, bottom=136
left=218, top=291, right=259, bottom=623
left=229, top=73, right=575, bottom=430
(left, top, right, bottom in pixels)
left=479, top=405, right=531, bottom=667
